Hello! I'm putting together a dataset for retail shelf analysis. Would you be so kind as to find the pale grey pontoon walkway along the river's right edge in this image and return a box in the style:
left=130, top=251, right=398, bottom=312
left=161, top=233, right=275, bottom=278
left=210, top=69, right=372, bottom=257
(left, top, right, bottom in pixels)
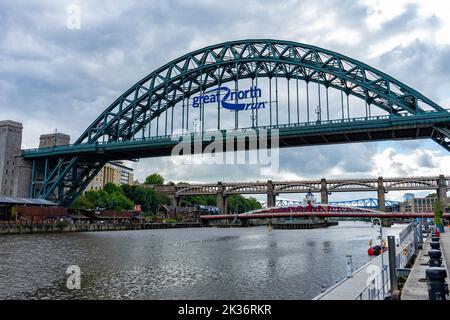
left=314, top=252, right=389, bottom=300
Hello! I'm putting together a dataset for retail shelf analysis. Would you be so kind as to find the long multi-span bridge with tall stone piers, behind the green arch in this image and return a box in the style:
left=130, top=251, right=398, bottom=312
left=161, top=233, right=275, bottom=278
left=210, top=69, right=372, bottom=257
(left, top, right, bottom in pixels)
left=155, top=175, right=450, bottom=213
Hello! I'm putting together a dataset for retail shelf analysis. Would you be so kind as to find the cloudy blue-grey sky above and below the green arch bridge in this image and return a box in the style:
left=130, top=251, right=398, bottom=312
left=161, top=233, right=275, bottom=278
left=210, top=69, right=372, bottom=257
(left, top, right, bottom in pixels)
left=0, top=0, right=450, bottom=200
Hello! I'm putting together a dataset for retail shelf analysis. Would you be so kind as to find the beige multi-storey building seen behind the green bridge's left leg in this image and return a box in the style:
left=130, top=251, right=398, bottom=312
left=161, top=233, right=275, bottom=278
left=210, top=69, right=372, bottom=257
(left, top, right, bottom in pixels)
left=86, top=161, right=133, bottom=190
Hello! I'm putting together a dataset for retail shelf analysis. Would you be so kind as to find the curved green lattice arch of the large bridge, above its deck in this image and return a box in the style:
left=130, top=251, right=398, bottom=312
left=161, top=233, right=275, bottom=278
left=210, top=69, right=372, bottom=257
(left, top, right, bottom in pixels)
left=76, top=40, right=446, bottom=144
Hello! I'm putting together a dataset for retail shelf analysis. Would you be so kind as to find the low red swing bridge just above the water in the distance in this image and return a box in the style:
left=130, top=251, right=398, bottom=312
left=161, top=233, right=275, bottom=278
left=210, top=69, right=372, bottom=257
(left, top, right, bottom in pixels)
left=200, top=204, right=450, bottom=222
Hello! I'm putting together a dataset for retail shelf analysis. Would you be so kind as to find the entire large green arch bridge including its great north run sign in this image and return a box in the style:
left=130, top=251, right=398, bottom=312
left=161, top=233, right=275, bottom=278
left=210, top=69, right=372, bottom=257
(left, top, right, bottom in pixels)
left=23, top=40, right=450, bottom=206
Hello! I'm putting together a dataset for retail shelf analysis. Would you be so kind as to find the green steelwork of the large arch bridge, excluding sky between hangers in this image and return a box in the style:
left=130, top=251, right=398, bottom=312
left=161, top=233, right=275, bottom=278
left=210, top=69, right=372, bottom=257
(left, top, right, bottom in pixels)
left=23, top=40, right=450, bottom=205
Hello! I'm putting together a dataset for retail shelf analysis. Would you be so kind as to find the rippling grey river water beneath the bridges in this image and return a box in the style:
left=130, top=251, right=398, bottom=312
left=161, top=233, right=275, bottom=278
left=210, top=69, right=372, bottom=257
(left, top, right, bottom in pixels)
left=0, top=222, right=402, bottom=299
